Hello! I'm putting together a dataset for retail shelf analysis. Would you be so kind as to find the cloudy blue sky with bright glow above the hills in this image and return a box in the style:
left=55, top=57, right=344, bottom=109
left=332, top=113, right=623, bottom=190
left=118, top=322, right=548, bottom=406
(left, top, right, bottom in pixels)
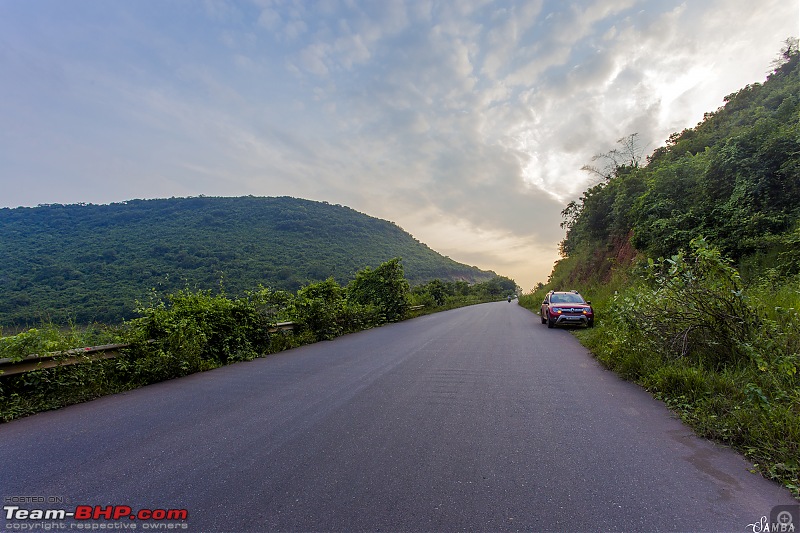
left=0, top=0, right=800, bottom=291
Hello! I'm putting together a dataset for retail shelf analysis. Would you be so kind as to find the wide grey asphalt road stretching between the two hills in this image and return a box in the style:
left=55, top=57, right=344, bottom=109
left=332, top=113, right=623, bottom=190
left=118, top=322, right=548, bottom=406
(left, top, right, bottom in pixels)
left=0, top=301, right=797, bottom=531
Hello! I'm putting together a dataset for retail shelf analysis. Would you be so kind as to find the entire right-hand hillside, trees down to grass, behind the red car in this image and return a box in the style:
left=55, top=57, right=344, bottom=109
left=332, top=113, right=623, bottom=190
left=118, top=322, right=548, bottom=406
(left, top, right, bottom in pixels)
left=520, top=39, right=800, bottom=496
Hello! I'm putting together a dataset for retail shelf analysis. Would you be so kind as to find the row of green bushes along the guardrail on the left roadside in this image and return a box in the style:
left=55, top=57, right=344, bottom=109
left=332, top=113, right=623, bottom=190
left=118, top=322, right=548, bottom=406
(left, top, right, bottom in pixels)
left=0, top=258, right=517, bottom=422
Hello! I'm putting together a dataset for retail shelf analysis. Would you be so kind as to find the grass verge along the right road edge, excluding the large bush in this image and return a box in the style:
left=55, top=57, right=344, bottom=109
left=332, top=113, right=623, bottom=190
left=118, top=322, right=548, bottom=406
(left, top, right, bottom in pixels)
left=520, top=260, right=800, bottom=498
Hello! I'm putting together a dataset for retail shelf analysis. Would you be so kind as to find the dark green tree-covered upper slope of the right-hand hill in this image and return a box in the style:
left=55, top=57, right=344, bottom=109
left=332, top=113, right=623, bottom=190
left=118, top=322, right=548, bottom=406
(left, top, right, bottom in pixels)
left=561, top=44, right=800, bottom=281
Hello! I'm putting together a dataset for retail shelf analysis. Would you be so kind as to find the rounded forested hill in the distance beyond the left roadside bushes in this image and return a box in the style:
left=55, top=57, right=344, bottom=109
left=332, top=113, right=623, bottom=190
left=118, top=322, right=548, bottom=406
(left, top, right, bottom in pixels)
left=0, top=196, right=494, bottom=326
